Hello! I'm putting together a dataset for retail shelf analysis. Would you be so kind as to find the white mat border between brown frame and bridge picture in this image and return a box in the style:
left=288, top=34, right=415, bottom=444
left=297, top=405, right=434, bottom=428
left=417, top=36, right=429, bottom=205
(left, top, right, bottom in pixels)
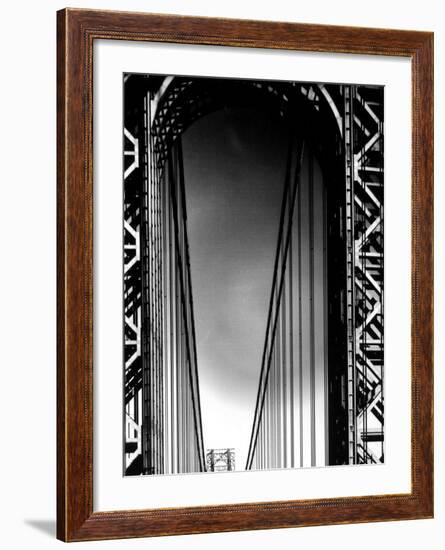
left=93, top=40, right=411, bottom=511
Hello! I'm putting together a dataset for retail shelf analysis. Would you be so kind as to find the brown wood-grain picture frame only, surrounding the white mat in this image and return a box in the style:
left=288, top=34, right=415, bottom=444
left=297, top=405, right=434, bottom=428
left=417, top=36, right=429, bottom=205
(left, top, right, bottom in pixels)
left=53, top=9, right=433, bottom=541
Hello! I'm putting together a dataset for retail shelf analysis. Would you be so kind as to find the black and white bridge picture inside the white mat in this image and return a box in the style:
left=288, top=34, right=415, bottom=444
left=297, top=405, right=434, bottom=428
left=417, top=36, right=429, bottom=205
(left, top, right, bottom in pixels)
left=123, top=73, right=384, bottom=476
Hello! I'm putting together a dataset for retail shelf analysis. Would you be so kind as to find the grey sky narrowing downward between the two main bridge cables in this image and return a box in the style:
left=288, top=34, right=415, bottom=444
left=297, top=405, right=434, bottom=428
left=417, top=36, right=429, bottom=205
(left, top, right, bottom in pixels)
left=183, top=105, right=287, bottom=470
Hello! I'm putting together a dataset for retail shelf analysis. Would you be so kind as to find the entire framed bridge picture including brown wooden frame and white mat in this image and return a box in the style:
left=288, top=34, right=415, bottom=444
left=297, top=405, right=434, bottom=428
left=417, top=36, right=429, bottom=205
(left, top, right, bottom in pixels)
left=57, top=9, right=433, bottom=541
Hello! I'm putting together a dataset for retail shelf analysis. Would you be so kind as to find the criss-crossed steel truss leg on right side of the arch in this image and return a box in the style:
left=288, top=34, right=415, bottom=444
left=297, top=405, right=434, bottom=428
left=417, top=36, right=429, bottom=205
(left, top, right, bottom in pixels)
left=344, top=86, right=384, bottom=464
